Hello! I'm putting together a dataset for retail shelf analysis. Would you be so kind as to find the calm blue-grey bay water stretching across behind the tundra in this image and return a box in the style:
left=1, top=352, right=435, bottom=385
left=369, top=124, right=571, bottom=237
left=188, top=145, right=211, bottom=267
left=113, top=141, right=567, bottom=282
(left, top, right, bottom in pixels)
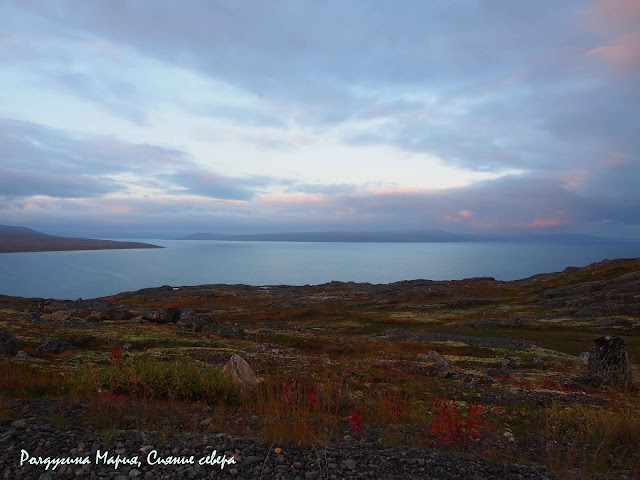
left=0, top=240, right=640, bottom=299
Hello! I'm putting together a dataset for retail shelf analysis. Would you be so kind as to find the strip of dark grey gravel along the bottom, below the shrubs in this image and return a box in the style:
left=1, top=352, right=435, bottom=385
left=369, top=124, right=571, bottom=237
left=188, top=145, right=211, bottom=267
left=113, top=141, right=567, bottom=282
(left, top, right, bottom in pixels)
left=0, top=419, right=553, bottom=480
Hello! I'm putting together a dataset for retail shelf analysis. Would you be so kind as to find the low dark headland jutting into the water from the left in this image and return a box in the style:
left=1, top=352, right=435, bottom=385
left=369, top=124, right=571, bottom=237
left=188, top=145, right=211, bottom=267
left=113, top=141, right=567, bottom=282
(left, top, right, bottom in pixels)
left=0, top=225, right=162, bottom=253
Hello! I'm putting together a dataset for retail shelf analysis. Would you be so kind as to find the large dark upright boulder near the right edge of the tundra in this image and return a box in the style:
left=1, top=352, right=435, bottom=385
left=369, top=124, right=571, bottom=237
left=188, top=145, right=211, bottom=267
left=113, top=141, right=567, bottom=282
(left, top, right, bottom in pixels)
left=589, top=335, right=631, bottom=390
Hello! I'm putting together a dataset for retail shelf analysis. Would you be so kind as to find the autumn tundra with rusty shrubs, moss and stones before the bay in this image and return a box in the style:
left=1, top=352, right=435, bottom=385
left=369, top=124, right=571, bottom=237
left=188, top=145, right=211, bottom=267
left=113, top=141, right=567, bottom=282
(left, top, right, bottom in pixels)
left=0, top=259, right=640, bottom=480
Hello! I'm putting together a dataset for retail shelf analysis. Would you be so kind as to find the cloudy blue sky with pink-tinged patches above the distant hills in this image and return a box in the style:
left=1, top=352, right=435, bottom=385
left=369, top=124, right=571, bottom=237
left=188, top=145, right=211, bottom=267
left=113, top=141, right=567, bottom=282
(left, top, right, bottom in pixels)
left=0, top=0, right=640, bottom=239
